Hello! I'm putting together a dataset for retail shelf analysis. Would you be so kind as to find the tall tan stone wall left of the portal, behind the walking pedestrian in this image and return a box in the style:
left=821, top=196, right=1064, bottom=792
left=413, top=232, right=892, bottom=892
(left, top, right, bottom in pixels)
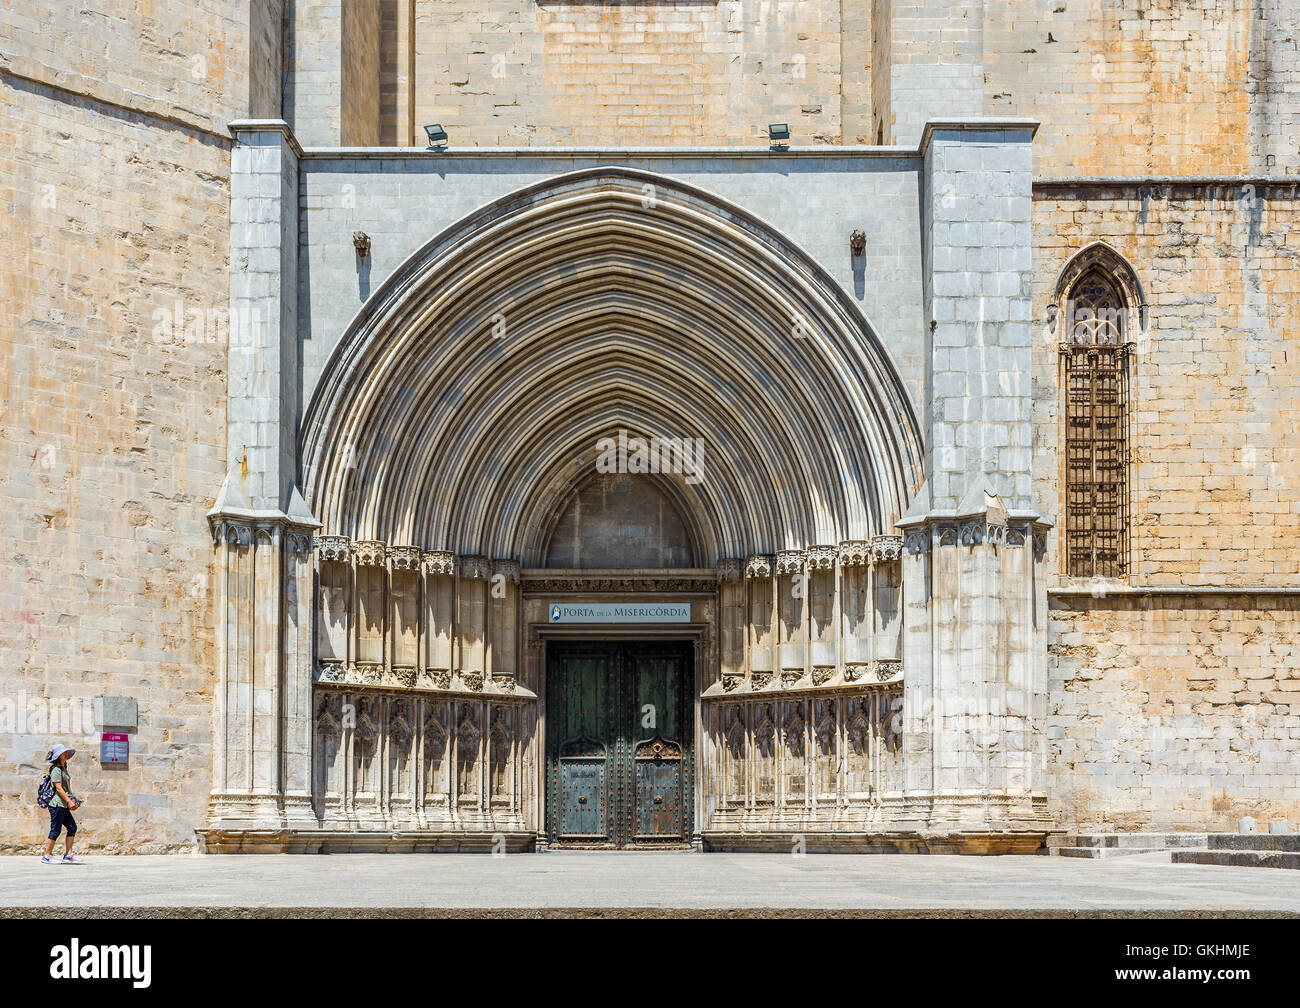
left=0, top=1, right=250, bottom=851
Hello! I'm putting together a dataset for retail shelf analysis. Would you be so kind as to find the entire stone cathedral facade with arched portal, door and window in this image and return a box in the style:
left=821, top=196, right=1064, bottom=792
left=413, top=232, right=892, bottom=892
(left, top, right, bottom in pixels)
left=0, top=0, right=1300, bottom=853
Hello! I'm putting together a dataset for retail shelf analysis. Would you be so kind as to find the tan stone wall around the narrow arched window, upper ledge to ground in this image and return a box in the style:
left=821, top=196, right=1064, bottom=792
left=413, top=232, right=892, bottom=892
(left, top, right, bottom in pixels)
left=1034, top=183, right=1300, bottom=830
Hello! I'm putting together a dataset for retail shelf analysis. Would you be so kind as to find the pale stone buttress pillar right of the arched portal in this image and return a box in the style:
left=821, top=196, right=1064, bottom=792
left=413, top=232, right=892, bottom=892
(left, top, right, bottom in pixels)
left=898, top=121, right=1050, bottom=851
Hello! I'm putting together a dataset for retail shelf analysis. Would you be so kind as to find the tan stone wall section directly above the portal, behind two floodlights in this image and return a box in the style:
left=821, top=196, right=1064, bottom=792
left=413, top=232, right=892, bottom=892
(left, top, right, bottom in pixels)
left=410, top=0, right=847, bottom=146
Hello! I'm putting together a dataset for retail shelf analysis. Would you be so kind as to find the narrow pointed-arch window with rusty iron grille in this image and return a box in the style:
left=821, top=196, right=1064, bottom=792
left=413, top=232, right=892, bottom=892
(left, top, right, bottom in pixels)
left=1056, top=245, right=1144, bottom=577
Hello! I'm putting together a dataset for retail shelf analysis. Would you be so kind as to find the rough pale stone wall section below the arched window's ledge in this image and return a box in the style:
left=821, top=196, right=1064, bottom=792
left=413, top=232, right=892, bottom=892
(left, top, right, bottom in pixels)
left=1048, top=594, right=1300, bottom=832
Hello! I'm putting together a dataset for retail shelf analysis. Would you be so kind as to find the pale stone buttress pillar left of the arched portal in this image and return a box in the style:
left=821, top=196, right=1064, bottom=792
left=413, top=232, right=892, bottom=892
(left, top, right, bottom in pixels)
left=204, top=121, right=319, bottom=851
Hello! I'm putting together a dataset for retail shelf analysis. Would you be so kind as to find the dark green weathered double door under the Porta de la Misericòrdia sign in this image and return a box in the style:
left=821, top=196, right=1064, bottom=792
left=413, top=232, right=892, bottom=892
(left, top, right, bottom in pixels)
left=546, top=643, right=694, bottom=847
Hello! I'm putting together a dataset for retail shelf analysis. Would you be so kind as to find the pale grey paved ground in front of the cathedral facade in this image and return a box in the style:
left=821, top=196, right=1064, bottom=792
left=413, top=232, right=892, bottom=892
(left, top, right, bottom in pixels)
left=0, top=852, right=1300, bottom=917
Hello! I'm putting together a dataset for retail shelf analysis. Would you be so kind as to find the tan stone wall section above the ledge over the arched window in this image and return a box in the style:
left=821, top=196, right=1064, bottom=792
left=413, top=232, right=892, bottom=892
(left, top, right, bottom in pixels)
left=987, top=0, right=1300, bottom=178
